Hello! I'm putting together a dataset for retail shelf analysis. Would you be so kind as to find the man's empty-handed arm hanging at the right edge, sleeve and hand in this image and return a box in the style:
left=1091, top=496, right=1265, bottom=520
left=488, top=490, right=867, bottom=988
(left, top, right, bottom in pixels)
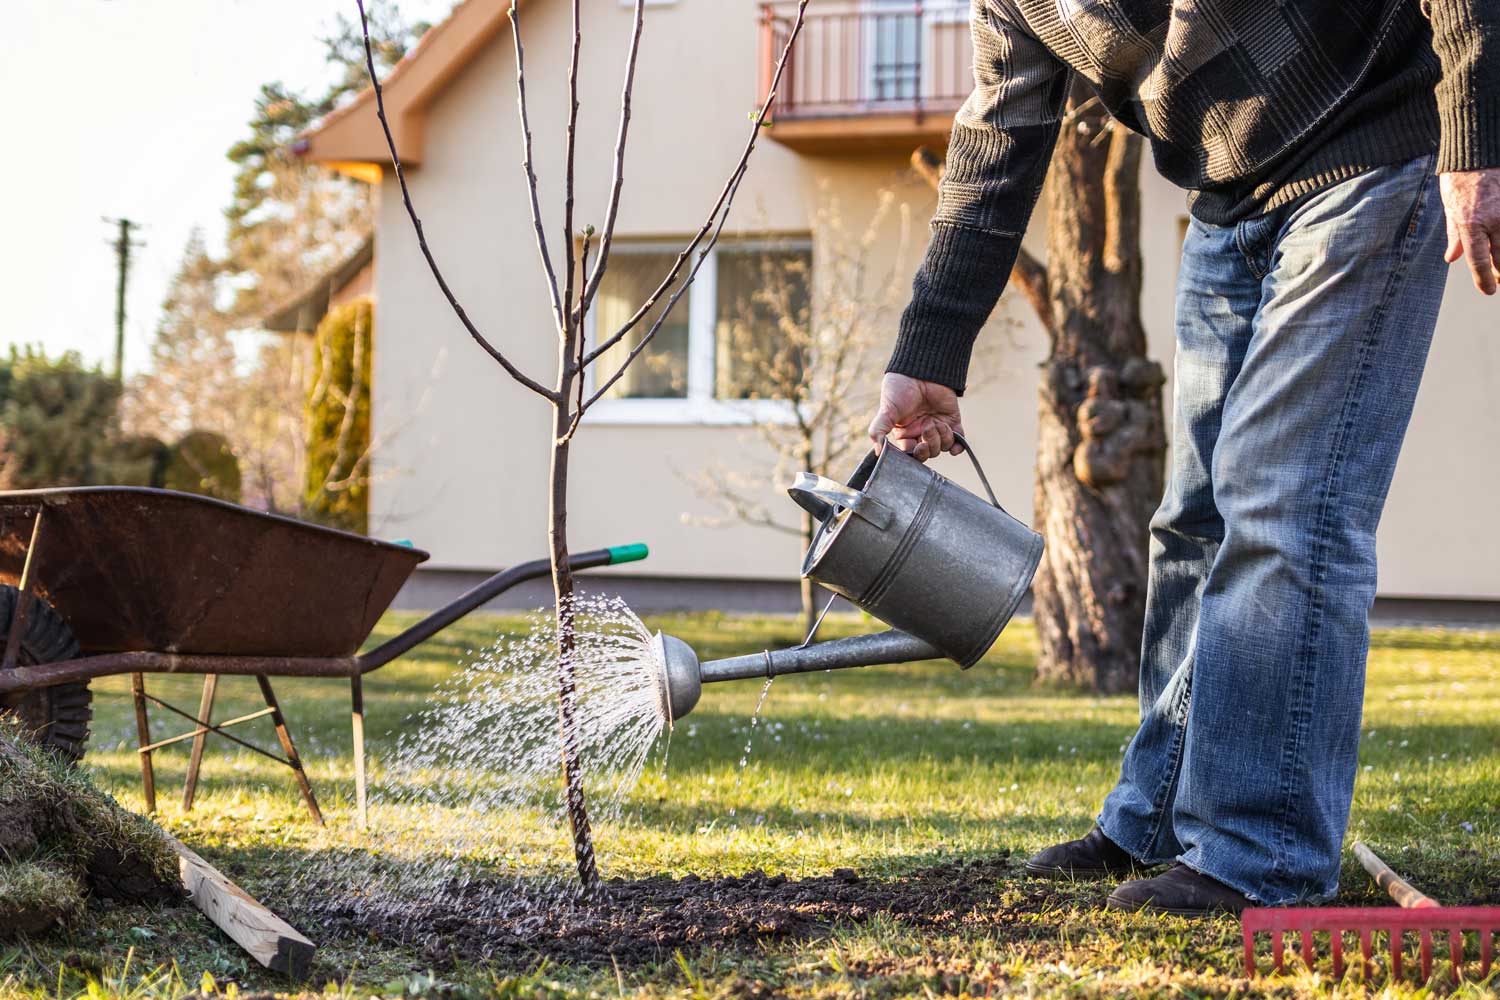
left=1424, top=0, right=1500, bottom=295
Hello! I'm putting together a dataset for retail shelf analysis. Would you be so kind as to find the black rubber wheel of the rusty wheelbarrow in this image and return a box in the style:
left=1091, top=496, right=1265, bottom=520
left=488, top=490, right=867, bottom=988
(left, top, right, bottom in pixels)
left=0, top=585, right=93, bottom=763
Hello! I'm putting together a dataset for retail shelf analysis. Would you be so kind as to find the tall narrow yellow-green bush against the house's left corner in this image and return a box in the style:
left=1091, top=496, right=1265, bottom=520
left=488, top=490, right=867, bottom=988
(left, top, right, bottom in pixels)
left=305, top=298, right=375, bottom=534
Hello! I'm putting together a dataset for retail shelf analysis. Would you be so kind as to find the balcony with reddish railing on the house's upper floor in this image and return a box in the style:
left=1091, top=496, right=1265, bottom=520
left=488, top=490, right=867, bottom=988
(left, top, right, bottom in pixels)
left=761, top=0, right=974, bottom=154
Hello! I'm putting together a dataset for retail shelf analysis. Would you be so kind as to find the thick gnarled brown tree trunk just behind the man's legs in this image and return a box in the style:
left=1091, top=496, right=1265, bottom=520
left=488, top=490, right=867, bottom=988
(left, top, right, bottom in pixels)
left=1017, top=88, right=1166, bottom=691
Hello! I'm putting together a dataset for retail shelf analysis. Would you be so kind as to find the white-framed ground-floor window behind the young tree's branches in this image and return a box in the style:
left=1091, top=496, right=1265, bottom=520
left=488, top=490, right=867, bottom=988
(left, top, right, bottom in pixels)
left=590, top=238, right=813, bottom=423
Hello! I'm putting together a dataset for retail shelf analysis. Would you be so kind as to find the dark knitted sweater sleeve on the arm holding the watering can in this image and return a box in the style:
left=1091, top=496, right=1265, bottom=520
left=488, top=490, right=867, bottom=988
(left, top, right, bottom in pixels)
left=885, top=0, right=1074, bottom=393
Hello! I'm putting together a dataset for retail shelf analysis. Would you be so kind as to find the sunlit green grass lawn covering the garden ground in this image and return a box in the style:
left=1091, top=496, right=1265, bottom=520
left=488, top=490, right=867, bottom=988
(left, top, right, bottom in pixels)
left=0, top=615, right=1500, bottom=997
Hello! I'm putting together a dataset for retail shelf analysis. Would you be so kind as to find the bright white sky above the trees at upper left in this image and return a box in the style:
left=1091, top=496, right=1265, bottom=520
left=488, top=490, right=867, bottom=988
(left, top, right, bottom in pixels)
left=0, top=0, right=453, bottom=370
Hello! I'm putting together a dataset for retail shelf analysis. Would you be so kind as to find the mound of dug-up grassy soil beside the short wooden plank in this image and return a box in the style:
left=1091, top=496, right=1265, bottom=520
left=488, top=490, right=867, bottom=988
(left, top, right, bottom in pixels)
left=0, top=726, right=183, bottom=940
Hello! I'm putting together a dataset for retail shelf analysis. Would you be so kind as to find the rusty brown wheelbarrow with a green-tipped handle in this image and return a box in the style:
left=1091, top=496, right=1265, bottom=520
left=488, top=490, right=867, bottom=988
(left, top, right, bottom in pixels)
left=0, top=486, right=647, bottom=826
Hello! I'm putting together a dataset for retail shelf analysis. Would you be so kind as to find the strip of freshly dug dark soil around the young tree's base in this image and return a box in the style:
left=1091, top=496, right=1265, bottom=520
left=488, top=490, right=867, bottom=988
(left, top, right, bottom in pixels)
left=300, top=855, right=1041, bottom=966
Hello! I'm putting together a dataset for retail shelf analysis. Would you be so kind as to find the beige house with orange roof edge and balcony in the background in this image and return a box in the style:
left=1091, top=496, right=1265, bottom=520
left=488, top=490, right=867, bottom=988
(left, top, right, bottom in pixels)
left=300, top=0, right=1500, bottom=615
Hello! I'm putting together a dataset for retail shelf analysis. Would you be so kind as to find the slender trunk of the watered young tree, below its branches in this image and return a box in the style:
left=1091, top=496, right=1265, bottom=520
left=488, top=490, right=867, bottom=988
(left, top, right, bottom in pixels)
left=548, top=380, right=599, bottom=897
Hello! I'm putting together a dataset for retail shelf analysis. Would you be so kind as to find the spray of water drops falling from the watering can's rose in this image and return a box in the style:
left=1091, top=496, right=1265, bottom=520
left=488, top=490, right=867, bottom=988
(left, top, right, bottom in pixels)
left=285, top=597, right=669, bottom=925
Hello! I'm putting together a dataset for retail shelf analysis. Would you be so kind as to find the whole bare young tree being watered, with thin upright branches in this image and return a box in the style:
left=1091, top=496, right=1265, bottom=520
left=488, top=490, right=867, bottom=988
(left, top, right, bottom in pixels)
left=356, top=0, right=809, bottom=894
